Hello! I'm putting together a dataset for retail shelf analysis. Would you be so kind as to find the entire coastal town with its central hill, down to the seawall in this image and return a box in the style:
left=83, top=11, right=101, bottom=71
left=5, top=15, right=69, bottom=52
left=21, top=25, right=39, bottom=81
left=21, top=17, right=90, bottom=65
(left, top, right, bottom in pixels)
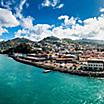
left=1, top=36, right=104, bottom=77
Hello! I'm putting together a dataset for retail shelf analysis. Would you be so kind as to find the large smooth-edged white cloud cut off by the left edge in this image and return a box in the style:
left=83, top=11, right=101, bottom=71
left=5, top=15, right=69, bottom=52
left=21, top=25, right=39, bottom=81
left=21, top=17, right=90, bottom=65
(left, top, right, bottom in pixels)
left=0, top=8, right=19, bottom=27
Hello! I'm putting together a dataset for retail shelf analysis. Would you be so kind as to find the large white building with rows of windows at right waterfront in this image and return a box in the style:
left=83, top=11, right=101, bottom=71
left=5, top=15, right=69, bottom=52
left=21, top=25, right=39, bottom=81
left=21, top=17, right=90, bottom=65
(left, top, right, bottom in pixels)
left=82, top=59, right=104, bottom=71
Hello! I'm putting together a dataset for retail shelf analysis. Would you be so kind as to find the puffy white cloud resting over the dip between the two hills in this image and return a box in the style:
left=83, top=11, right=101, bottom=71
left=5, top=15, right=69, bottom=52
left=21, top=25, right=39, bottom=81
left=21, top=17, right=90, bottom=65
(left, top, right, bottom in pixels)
left=15, top=24, right=53, bottom=41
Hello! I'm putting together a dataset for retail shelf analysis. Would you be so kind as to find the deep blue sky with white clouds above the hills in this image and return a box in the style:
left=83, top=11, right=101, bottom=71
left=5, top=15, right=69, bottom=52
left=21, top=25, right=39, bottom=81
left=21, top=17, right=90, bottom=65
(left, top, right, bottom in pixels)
left=0, top=0, right=104, bottom=41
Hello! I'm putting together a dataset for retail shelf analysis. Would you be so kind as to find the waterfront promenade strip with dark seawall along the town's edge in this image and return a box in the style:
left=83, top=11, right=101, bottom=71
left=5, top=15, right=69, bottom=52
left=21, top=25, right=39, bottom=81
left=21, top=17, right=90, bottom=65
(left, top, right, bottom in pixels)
left=12, top=56, right=104, bottom=77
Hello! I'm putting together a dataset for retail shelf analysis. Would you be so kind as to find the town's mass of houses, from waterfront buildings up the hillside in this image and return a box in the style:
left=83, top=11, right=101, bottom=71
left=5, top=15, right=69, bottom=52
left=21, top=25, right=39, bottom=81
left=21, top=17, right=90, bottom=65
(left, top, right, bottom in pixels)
left=15, top=37, right=104, bottom=71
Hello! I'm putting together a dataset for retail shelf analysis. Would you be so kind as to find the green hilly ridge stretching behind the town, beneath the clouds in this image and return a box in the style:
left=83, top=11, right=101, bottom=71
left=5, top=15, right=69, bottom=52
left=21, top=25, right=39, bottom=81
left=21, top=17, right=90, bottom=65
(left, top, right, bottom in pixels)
left=0, top=36, right=104, bottom=53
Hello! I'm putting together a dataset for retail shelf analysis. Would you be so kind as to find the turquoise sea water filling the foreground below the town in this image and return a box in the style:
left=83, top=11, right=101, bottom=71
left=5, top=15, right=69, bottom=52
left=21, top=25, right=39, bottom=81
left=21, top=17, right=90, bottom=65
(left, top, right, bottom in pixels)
left=0, top=55, right=104, bottom=104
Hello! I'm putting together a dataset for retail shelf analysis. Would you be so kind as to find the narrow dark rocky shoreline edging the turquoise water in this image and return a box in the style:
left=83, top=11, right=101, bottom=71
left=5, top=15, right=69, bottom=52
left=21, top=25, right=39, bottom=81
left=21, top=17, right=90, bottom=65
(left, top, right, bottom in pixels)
left=11, top=56, right=104, bottom=77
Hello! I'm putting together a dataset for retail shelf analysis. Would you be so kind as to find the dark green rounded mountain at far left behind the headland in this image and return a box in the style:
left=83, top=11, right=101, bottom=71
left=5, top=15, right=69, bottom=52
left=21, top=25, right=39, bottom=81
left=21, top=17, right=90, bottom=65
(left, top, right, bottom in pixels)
left=0, top=38, right=34, bottom=50
